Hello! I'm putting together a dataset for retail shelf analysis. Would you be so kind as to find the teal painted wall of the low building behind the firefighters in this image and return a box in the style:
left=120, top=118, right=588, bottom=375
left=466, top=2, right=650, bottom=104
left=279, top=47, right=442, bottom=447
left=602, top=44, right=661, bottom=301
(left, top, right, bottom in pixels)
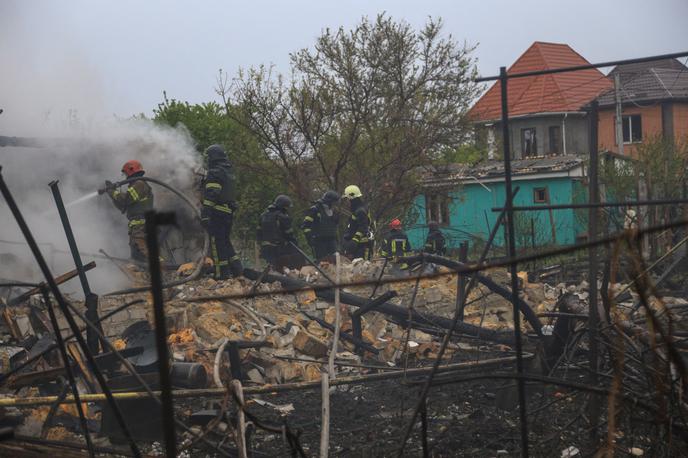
left=406, top=177, right=587, bottom=249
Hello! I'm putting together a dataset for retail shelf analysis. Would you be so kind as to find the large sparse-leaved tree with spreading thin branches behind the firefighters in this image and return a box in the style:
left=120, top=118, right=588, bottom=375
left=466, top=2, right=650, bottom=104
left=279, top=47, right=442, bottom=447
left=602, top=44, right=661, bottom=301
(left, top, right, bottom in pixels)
left=223, top=14, right=479, bottom=229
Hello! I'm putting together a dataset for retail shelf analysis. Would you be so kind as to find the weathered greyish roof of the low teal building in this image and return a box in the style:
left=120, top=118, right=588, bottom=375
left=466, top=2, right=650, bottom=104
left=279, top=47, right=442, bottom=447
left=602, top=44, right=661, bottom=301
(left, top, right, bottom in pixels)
left=421, top=155, right=584, bottom=187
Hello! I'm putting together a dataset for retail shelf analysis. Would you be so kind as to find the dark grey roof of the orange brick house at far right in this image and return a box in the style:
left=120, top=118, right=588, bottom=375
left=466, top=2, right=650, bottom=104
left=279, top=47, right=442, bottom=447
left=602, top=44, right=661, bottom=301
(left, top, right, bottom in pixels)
left=597, top=59, right=688, bottom=106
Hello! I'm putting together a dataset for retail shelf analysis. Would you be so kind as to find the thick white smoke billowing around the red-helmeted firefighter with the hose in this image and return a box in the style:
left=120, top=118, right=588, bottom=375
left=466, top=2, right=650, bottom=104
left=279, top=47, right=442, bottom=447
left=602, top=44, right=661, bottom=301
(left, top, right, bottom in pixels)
left=0, top=120, right=202, bottom=292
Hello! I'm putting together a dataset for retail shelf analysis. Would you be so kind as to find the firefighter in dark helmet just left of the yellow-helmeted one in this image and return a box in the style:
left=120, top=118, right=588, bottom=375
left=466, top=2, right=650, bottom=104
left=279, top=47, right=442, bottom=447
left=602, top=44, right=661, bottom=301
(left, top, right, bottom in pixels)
left=301, top=191, right=339, bottom=259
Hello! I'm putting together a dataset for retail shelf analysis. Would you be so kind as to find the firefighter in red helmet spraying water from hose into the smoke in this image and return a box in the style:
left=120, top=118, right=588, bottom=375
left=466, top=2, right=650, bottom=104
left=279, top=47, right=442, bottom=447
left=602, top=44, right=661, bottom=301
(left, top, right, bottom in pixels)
left=105, top=159, right=153, bottom=262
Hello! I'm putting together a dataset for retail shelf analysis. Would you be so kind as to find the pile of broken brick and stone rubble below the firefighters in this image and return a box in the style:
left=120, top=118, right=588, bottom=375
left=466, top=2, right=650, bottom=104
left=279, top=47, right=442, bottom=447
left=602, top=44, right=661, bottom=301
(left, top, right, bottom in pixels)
left=0, top=260, right=688, bottom=454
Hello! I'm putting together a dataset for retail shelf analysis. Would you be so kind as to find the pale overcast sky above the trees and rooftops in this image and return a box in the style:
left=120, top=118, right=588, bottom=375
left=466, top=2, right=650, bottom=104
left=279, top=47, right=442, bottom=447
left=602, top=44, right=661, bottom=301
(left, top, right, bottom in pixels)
left=0, top=0, right=688, bottom=134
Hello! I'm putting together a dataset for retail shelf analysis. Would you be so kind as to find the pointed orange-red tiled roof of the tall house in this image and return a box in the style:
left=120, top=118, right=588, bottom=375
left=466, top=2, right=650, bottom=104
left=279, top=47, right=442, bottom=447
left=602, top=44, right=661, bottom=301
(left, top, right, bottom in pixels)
left=470, top=41, right=611, bottom=121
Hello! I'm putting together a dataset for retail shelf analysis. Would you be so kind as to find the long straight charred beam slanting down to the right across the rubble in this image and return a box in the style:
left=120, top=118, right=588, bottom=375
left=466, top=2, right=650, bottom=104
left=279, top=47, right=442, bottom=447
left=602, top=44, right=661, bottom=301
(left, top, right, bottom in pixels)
left=244, top=269, right=513, bottom=345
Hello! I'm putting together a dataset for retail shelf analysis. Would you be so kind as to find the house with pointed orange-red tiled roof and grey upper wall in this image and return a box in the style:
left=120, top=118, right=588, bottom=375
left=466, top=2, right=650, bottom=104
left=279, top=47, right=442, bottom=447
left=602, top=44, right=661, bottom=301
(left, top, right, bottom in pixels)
left=469, top=41, right=612, bottom=159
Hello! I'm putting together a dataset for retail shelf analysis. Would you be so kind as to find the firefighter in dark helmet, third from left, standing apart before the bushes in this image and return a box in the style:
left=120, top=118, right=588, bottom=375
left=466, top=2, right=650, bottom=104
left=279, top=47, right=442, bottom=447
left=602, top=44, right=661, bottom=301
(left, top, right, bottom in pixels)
left=257, top=195, right=296, bottom=270
